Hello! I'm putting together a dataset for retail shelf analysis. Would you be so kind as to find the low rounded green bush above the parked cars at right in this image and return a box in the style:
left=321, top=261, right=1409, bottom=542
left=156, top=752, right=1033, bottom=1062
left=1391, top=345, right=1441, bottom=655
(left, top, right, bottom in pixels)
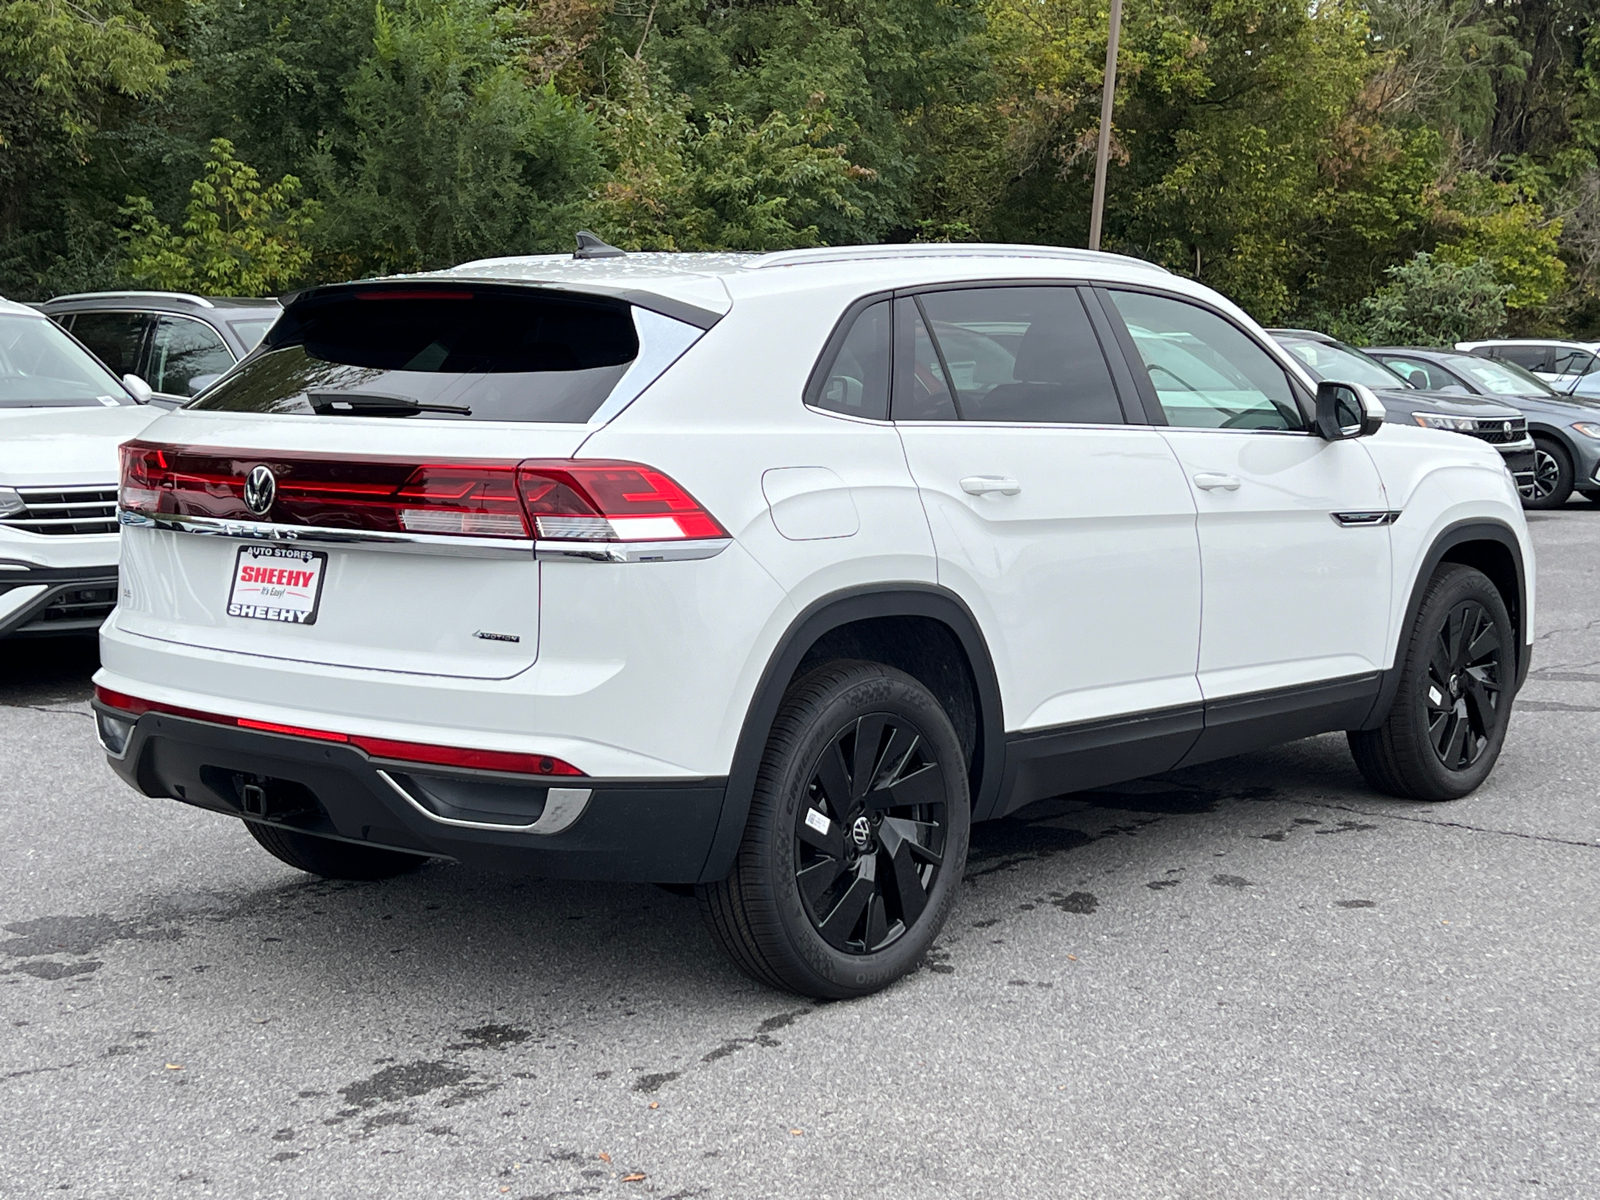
left=1357, top=253, right=1510, bottom=346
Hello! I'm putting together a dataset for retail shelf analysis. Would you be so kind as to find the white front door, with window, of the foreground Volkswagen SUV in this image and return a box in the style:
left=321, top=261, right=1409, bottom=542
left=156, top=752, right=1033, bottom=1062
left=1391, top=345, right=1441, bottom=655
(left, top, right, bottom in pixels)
left=1102, top=290, right=1390, bottom=713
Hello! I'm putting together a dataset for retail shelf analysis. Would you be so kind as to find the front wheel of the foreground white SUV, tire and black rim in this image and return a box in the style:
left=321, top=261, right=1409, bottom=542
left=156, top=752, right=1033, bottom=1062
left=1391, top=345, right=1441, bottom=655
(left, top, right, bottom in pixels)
left=1347, top=563, right=1518, bottom=800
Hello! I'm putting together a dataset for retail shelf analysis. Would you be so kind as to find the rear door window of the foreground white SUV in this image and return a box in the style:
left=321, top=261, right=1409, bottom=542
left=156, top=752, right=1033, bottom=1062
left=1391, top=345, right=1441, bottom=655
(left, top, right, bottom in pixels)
left=896, top=286, right=1123, bottom=424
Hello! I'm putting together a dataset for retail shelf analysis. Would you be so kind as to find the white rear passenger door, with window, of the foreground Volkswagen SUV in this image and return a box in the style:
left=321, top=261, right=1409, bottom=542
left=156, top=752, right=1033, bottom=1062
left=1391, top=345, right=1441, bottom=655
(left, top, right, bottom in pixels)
left=893, top=285, right=1200, bottom=755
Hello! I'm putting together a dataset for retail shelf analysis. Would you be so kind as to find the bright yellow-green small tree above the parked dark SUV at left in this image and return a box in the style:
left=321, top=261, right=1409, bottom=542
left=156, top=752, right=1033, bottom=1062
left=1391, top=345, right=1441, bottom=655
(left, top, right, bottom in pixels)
left=123, top=138, right=317, bottom=296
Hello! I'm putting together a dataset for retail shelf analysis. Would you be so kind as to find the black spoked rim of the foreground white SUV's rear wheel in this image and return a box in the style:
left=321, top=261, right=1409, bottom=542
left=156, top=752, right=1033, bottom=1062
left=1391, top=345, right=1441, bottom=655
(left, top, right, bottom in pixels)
left=795, top=714, right=946, bottom=954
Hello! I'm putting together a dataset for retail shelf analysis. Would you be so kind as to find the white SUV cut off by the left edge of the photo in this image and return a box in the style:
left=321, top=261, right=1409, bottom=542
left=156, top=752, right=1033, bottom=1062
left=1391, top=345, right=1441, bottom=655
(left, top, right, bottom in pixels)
left=0, top=299, right=160, bottom=638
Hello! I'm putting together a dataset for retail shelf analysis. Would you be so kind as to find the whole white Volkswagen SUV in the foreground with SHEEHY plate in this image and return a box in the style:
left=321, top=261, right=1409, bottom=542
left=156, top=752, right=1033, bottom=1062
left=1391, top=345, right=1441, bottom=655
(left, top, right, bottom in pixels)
left=94, top=245, right=1534, bottom=997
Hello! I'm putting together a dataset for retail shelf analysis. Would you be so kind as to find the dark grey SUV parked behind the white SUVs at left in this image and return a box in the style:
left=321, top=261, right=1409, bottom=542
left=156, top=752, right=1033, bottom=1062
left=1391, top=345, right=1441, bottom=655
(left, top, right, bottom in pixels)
left=38, top=291, right=283, bottom=400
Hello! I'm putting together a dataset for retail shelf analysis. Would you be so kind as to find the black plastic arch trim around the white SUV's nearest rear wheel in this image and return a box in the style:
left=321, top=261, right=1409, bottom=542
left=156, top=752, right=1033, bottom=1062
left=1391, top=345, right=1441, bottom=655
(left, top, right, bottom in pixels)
left=701, top=582, right=1006, bottom=883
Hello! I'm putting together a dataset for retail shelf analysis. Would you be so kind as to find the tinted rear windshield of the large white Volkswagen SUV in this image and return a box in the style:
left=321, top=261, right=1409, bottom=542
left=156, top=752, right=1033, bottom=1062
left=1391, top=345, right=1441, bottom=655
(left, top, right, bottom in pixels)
left=198, top=288, right=638, bottom=424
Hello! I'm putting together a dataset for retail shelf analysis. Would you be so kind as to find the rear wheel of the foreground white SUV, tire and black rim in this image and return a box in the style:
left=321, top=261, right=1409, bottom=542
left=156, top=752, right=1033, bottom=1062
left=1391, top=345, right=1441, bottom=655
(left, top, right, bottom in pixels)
left=698, top=661, right=971, bottom=1000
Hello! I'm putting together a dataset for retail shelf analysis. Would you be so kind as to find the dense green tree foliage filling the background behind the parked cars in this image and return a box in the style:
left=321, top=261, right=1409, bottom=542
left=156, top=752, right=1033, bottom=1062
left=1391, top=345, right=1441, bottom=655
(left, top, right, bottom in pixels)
left=0, top=0, right=1600, bottom=339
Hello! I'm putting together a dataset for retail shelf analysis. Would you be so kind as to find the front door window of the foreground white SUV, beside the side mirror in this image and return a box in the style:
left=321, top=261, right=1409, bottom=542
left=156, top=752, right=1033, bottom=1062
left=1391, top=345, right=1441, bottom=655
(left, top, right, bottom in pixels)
left=1109, top=291, right=1306, bottom=429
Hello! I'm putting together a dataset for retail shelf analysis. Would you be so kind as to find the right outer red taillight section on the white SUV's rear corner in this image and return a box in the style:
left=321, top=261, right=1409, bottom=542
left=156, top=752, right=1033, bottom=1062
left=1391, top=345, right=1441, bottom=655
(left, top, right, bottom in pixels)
left=517, top=459, right=728, bottom=542
